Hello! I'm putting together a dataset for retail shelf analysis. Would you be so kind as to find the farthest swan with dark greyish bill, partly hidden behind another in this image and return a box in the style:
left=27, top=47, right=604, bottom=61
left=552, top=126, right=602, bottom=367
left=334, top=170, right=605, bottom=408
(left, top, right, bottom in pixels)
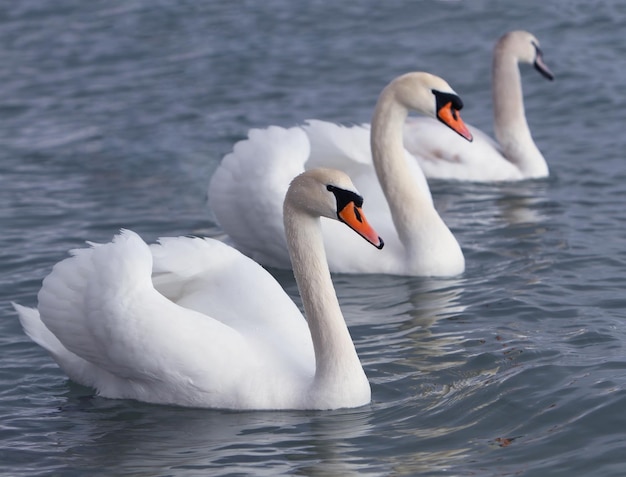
left=404, top=31, right=554, bottom=182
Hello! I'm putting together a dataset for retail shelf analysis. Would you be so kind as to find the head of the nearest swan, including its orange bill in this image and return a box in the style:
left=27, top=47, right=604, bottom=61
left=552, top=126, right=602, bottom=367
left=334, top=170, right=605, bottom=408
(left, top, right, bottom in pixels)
left=285, top=168, right=384, bottom=249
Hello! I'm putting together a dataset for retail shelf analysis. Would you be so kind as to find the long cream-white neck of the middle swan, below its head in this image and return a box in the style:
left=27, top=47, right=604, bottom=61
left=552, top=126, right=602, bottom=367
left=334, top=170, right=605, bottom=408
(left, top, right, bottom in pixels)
left=370, top=87, right=445, bottom=253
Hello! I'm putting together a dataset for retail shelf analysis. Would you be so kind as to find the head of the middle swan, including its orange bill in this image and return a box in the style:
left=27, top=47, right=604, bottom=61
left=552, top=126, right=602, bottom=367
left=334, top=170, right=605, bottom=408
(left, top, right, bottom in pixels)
left=383, top=72, right=472, bottom=141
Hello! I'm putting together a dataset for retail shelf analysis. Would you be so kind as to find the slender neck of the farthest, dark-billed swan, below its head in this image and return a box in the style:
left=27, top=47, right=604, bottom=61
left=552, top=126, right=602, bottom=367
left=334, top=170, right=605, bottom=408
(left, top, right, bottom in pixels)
left=492, top=49, right=548, bottom=177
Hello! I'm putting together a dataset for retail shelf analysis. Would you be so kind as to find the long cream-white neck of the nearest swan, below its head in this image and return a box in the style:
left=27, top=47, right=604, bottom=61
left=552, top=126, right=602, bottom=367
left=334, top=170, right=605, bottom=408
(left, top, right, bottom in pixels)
left=284, top=202, right=369, bottom=396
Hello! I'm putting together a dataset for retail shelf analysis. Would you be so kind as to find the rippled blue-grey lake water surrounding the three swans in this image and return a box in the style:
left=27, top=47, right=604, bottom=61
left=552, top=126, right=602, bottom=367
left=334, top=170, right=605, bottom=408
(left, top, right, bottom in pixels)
left=0, top=0, right=626, bottom=476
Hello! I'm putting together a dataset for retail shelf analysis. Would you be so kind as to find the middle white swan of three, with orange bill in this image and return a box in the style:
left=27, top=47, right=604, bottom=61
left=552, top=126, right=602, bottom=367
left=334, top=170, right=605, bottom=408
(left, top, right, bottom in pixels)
left=209, top=73, right=471, bottom=276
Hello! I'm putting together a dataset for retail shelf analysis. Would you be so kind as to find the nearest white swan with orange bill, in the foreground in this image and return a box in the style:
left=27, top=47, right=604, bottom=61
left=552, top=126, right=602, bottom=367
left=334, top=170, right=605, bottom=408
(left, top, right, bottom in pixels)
left=14, top=169, right=383, bottom=409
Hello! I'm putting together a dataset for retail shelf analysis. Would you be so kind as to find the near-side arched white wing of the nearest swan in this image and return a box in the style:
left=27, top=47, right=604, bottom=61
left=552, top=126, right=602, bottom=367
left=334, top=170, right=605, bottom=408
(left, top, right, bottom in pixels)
left=39, top=232, right=312, bottom=394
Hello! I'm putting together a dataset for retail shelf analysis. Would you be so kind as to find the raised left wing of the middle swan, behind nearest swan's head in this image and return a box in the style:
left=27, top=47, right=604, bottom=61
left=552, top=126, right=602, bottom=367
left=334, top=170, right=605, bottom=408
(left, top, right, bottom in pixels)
left=209, top=126, right=310, bottom=268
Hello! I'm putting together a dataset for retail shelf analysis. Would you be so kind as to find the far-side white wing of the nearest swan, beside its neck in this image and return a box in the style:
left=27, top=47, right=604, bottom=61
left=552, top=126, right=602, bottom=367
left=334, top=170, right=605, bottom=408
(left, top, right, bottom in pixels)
left=150, top=237, right=310, bottom=342
